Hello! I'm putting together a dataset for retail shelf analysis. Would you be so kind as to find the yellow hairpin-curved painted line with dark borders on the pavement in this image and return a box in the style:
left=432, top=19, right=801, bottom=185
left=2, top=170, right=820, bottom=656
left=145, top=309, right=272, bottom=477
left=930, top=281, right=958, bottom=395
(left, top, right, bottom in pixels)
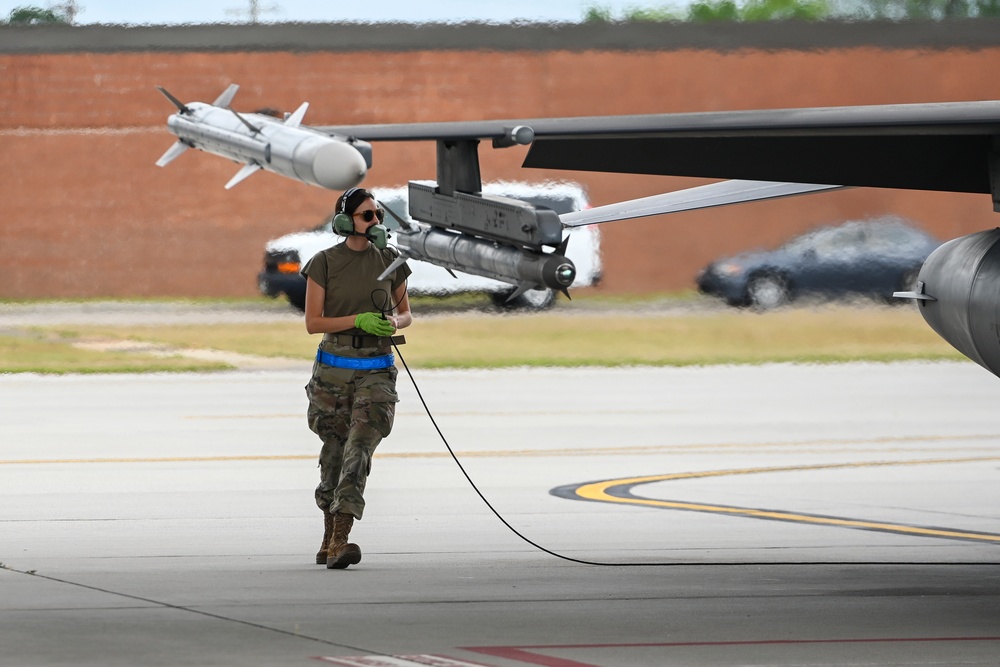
left=574, top=456, right=1000, bottom=544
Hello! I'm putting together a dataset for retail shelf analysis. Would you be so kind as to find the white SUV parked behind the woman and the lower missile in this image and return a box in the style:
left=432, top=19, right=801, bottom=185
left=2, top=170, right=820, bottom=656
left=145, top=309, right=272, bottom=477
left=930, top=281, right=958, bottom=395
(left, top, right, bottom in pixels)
left=258, top=181, right=601, bottom=310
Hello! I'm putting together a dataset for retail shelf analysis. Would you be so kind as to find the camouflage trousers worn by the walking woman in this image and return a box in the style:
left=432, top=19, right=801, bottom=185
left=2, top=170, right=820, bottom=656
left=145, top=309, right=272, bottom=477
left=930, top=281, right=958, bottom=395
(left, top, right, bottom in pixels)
left=306, top=342, right=399, bottom=519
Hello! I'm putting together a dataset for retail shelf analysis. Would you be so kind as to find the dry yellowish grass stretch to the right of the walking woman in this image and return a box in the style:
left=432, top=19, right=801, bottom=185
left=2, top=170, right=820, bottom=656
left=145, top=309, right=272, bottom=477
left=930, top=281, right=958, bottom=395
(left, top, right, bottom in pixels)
left=403, top=308, right=964, bottom=368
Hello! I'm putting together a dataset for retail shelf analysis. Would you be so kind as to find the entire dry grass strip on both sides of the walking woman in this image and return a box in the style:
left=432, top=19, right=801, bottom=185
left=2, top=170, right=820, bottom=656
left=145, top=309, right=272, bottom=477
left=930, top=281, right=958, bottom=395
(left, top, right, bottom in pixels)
left=13, top=307, right=965, bottom=372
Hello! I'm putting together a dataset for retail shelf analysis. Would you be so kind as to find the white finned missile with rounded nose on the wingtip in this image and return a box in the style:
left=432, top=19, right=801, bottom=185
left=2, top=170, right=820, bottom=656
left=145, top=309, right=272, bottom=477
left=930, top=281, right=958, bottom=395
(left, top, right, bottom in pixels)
left=150, top=84, right=371, bottom=190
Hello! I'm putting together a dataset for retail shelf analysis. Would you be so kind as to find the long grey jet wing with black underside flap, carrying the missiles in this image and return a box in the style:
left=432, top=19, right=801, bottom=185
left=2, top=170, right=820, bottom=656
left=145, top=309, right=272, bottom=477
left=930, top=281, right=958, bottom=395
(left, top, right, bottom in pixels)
left=314, top=101, right=1000, bottom=193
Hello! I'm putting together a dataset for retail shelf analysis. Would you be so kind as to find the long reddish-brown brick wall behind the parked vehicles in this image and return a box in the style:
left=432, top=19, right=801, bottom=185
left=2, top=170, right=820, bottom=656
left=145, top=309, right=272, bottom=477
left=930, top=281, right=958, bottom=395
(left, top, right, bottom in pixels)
left=0, top=24, right=1000, bottom=299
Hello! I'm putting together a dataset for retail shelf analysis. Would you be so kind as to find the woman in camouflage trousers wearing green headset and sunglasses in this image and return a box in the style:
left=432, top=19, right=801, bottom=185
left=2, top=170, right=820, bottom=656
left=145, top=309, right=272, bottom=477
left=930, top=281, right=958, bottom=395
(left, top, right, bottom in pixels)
left=302, top=188, right=412, bottom=569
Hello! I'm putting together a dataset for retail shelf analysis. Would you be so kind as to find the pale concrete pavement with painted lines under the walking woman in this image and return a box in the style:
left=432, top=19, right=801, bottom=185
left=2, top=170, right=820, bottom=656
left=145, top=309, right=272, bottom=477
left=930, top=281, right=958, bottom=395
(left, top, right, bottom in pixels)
left=0, top=363, right=1000, bottom=667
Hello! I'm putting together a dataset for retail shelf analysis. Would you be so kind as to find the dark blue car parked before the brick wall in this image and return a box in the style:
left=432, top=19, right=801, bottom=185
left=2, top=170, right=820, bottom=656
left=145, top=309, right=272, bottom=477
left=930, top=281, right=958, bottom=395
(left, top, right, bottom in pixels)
left=697, top=217, right=941, bottom=309
